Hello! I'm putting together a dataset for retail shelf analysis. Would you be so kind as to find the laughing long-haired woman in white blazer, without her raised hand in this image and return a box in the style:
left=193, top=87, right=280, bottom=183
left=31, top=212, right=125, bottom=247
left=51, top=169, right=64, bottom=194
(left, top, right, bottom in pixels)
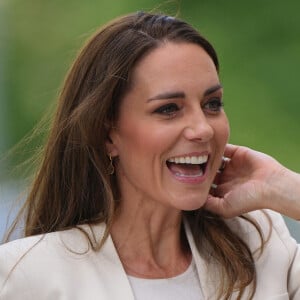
left=0, top=12, right=300, bottom=299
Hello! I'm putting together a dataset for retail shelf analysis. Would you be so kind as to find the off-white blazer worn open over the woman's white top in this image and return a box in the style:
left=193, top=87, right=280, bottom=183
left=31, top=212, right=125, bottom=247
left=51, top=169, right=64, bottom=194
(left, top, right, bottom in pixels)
left=0, top=211, right=300, bottom=300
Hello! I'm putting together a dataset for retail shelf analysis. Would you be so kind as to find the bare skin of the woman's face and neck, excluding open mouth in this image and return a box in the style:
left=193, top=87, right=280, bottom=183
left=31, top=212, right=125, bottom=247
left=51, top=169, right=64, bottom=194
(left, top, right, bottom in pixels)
left=107, top=42, right=229, bottom=278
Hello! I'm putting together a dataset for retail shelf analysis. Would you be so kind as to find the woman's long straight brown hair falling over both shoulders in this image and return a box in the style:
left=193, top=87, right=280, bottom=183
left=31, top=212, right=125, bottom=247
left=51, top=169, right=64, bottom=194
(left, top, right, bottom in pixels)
left=8, top=12, right=264, bottom=299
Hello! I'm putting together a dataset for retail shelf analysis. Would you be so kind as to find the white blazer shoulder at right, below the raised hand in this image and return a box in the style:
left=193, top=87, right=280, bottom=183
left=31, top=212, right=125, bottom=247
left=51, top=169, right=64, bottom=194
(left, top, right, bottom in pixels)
left=227, top=210, right=300, bottom=299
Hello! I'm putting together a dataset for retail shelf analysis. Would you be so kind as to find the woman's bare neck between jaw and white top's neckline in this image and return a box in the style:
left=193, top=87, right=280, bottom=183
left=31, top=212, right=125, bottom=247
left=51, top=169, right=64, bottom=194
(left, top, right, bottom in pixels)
left=111, top=201, right=191, bottom=278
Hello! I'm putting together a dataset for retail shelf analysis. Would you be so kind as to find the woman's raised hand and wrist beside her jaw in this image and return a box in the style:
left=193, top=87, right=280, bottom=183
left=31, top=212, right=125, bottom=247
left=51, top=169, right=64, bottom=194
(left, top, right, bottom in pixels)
left=205, top=145, right=300, bottom=219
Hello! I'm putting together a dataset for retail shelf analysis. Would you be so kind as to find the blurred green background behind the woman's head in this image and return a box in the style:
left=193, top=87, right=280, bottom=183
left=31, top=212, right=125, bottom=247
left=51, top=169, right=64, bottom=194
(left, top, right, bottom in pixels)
left=0, top=0, right=300, bottom=239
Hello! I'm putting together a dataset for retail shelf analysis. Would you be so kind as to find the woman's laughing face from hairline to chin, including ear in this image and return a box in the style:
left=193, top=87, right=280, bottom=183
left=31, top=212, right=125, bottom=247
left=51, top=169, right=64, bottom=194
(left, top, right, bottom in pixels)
left=108, top=42, right=229, bottom=210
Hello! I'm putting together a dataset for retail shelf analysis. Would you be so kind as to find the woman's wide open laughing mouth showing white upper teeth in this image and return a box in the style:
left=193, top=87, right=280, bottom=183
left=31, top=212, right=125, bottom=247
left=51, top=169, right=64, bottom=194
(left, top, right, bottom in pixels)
left=167, top=155, right=208, bottom=178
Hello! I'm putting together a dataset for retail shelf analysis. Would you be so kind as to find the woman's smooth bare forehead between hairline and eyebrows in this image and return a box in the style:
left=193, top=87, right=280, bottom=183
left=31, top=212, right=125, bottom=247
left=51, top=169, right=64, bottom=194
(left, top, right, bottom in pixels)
left=132, top=42, right=218, bottom=88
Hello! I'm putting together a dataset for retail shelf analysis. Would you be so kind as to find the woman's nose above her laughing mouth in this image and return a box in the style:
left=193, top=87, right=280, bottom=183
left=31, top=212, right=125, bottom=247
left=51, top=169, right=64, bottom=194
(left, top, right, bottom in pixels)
left=184, top=108, right=214, bottom=142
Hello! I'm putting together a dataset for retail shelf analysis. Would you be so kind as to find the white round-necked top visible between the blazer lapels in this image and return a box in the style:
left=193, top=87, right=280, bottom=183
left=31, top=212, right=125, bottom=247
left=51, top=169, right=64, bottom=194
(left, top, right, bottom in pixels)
left=128, top=259, right=204, bottom=300
